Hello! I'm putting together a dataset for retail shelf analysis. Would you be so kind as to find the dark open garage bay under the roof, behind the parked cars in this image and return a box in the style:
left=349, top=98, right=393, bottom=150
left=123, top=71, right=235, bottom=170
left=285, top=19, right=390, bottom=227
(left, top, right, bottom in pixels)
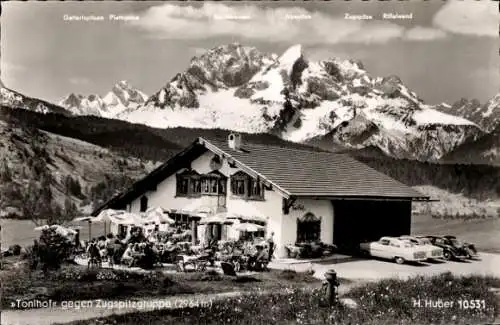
left=332, top=200, right=411, bottom=253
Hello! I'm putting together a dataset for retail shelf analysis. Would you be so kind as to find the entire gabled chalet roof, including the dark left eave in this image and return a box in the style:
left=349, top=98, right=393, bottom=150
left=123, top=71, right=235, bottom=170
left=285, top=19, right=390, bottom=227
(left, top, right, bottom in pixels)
left=92, top=138, right=429, bottom=215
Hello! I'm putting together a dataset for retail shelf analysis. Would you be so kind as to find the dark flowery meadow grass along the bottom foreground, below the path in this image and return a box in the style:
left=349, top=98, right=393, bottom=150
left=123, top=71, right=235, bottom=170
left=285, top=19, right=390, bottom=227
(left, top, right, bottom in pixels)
left=60, top=273, right=500, bottom=325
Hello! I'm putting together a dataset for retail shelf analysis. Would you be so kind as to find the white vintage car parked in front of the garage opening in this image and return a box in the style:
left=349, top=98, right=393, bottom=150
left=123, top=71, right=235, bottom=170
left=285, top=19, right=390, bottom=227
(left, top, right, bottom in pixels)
left=359, top=237, right=427, bottom=264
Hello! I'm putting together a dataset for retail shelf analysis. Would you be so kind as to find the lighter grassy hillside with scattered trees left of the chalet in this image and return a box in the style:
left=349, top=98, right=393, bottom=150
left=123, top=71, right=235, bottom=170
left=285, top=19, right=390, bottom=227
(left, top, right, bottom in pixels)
left=0, top=121, right=154, bottom=220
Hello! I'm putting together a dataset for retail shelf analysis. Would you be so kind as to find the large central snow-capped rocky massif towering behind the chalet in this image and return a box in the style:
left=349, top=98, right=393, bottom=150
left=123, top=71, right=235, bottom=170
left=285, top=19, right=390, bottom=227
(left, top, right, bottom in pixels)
left=113, top=44, right=482, bottom=160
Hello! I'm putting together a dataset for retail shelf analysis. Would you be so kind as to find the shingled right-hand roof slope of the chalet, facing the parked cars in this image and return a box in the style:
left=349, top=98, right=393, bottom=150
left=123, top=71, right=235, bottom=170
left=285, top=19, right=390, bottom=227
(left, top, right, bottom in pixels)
left=200, top=138, right=427, bottom=199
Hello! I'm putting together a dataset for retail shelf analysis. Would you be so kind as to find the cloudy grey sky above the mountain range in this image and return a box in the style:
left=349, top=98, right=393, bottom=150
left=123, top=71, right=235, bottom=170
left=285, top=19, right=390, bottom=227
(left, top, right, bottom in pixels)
left=0, top=0, right=500, bottom=104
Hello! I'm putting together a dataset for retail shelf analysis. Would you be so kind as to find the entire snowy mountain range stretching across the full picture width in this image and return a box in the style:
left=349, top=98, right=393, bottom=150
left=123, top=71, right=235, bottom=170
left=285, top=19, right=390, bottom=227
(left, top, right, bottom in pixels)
left=0, top=44, right=500, bottom=164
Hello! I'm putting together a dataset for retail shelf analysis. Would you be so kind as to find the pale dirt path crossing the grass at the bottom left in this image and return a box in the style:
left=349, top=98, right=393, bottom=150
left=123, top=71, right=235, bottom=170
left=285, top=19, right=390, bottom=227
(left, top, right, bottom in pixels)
left=1, top=284, right=352, bottom=325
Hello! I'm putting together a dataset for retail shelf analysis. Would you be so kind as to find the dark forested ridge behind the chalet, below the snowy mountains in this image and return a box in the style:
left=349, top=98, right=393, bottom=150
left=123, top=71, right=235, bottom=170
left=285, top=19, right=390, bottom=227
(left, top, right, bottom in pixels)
left=0, top=106, right=326, bottom=161
